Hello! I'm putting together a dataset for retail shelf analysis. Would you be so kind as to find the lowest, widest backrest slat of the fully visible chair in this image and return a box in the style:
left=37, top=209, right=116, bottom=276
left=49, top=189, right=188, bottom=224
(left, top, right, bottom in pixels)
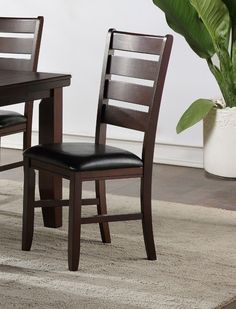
left=102, top=105, right=148, bottom=132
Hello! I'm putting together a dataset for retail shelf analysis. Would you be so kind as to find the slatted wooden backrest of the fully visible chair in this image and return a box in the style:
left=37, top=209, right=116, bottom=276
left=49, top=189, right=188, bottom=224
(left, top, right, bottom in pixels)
left=96, top=29, right=173, bottom=166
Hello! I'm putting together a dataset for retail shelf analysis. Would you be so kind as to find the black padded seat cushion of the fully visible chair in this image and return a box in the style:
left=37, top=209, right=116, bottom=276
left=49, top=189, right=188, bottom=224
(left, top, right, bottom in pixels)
left=24, top=143, right=143, bottom=171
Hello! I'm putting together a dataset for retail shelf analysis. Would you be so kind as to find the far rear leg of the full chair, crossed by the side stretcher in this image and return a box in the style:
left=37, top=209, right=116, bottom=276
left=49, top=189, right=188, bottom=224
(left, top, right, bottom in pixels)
left=95, top=180, right=111, bottom=243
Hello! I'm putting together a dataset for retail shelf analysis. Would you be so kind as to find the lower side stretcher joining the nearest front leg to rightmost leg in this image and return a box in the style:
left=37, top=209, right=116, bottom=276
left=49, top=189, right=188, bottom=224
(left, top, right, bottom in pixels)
left=81, top=213, right=143, bottom=224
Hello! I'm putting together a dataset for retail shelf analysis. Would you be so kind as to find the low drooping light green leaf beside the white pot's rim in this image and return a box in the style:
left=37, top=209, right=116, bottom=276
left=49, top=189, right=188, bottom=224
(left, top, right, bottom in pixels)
left=176, top=99, right=215, bottom=133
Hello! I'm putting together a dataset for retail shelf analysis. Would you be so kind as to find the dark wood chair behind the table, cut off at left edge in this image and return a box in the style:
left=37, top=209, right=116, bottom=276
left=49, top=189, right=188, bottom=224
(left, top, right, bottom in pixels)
left=0, top=16, right=43, bottom=172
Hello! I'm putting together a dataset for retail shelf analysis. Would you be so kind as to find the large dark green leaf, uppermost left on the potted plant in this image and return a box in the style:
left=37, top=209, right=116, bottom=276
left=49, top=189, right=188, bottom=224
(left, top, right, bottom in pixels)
left=153, top=0, right=215, bottom=59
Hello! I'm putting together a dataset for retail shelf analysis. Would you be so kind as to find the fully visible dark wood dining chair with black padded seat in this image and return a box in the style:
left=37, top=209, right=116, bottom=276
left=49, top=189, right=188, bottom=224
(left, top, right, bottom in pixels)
left=22, top=30, right=173, bottom=270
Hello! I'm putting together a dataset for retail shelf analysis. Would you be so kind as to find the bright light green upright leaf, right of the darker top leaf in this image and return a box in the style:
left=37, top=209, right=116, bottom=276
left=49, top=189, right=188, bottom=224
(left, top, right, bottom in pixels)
left=190, top=0, right=231, bottom=50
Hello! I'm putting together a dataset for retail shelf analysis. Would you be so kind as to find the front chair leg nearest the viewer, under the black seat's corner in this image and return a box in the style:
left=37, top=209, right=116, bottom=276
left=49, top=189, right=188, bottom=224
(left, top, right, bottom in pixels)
left=68, top=173, right=82, bottom=271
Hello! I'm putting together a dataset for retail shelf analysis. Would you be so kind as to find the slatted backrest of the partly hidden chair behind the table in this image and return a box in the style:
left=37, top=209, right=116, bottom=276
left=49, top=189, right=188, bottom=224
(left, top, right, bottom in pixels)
left=0, top=16, right=44, bottom=119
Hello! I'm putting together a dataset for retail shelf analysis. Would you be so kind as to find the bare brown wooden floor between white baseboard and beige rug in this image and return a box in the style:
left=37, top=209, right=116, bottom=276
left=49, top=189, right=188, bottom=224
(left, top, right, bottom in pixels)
left=0, top=149, right=236, bottom=309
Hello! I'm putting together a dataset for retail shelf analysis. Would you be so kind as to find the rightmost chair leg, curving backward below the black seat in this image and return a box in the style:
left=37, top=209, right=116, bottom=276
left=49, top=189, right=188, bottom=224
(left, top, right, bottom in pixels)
left=141, top=177, right=156, bottom=260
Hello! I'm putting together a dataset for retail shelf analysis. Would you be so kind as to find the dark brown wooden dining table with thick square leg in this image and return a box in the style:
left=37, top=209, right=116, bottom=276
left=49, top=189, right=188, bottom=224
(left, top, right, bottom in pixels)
left=0, top=70, right=71, bottom=228
